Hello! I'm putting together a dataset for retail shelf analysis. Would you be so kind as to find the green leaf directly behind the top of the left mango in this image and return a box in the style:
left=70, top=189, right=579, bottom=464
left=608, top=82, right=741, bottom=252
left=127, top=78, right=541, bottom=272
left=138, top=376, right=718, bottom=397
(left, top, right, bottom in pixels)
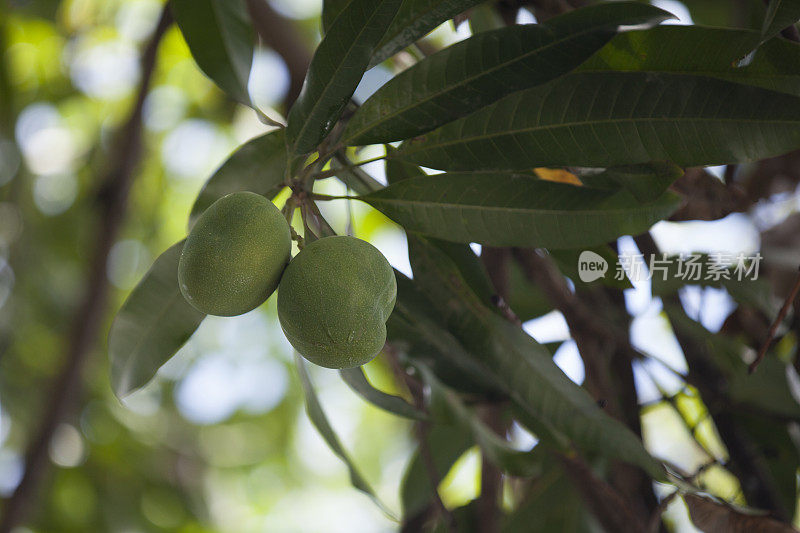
left=189, top=130, right=286, bottom=228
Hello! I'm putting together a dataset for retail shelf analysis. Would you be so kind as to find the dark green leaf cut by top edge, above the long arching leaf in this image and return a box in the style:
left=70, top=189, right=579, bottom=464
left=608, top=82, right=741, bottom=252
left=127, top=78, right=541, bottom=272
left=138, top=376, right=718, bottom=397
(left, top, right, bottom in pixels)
left=370, top=0, right=484, bottom=67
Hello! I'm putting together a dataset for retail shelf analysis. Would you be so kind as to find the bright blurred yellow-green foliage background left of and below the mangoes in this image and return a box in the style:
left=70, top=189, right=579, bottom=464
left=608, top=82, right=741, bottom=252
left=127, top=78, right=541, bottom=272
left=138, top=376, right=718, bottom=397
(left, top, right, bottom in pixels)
left=0, top=0, right=410, bottom=533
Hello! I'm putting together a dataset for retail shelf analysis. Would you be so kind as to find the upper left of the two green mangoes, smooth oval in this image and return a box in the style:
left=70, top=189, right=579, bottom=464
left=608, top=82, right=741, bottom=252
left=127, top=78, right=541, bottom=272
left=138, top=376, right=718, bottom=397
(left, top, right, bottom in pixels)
left=178, top=192, right=292, bottom=316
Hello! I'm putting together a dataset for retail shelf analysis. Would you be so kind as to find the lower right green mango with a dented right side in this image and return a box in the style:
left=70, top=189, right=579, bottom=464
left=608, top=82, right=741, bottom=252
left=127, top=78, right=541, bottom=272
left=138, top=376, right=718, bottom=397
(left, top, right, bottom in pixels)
left=278, top=236, right=397, bottom=369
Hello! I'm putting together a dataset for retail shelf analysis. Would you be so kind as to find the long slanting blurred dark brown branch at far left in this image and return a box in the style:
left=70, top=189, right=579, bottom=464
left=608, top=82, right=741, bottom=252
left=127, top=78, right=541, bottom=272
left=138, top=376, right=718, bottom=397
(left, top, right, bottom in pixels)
left=0, top=8, right=172, bottom=533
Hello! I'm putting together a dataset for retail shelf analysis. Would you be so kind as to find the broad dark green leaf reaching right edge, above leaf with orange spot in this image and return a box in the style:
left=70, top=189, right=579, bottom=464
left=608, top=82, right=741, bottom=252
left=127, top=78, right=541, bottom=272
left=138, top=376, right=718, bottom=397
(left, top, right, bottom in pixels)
left=400, top=72, right=800, bottom=170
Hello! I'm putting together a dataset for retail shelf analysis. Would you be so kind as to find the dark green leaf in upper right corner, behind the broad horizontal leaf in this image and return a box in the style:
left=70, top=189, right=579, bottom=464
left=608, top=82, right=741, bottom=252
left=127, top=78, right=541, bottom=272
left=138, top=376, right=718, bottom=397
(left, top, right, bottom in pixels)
left=578, top=26, right=800, bottom=96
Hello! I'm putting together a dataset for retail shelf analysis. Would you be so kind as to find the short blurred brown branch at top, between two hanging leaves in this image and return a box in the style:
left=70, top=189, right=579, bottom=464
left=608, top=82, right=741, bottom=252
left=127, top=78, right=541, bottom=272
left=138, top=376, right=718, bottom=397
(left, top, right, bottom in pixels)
left=247, top=0, right=311, bottom=110
